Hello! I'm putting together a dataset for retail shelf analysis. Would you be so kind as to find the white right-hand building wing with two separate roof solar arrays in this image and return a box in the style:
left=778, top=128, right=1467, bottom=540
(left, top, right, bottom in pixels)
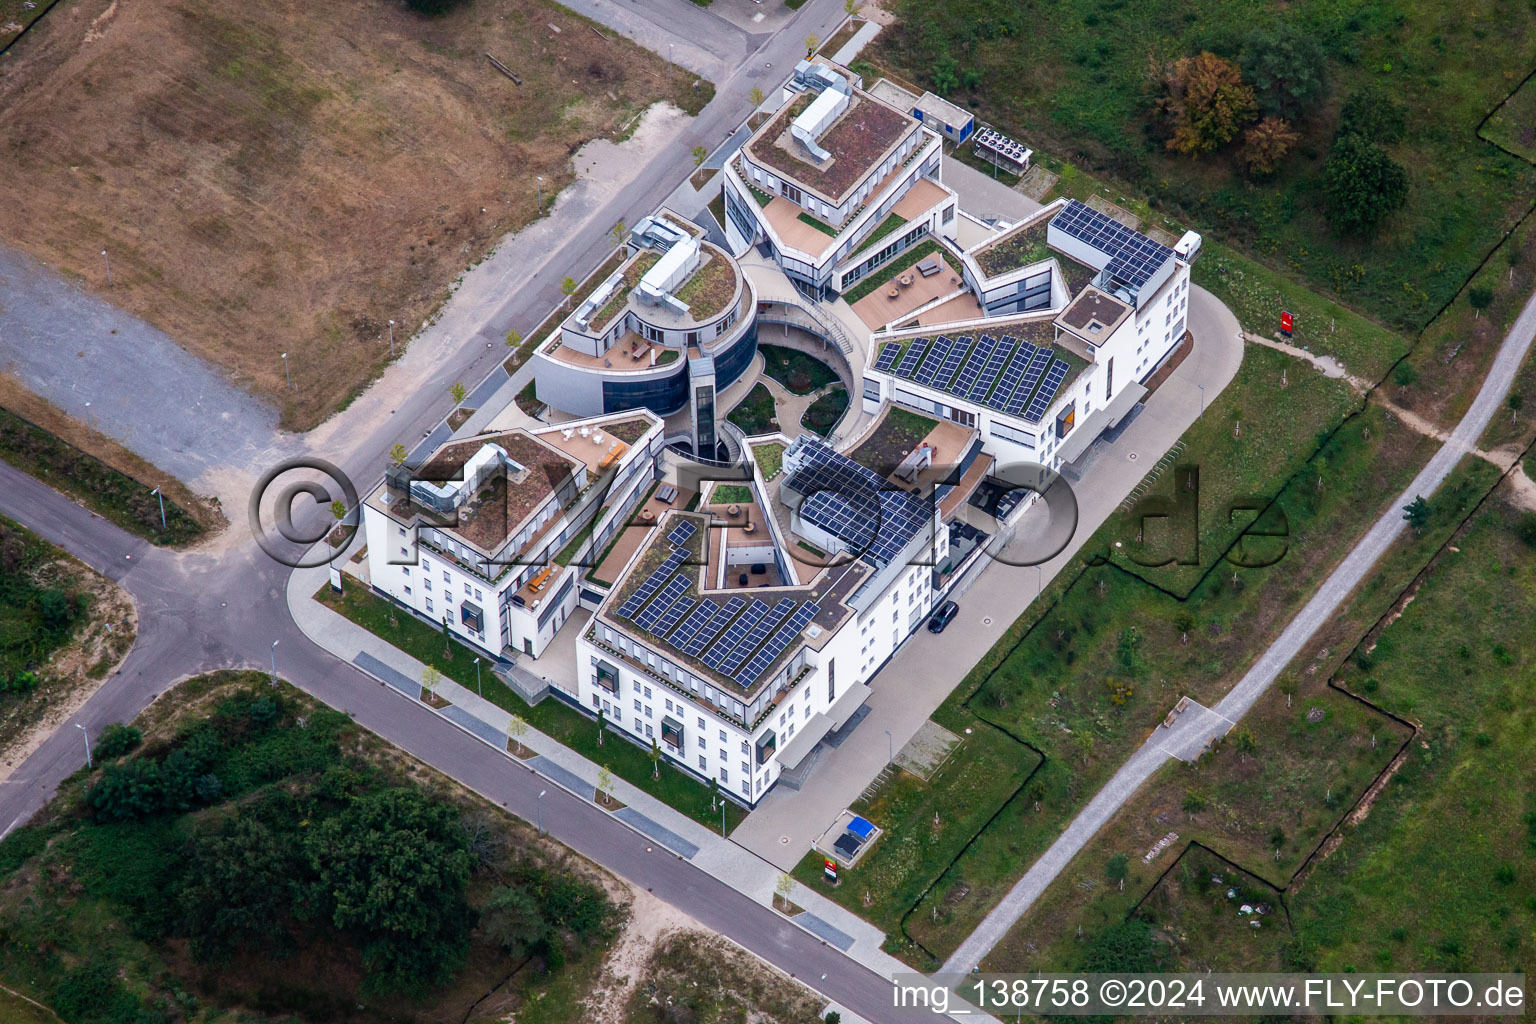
left=863, top=200, right=1200, bottom=470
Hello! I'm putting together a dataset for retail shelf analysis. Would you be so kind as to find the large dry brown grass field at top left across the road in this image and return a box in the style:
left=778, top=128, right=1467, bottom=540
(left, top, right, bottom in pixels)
left=0, top=0, right=711, bottom=428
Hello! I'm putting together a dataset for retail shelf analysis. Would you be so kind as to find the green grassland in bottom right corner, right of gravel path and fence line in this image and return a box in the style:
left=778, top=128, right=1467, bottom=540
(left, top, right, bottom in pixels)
left=1292, top=499, right=1536, bottom=970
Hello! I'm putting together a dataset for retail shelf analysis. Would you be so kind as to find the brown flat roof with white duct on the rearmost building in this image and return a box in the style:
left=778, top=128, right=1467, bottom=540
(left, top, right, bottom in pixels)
left=746, top=81, right=919, bottom=206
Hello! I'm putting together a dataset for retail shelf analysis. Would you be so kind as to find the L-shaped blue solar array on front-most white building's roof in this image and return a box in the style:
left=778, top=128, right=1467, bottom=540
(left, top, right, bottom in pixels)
left=617, top=512, right=835, bottom=688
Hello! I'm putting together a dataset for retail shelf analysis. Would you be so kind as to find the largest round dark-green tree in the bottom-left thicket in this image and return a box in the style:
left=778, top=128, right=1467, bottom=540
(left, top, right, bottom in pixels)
left=303, top=786, right=475, bottom=992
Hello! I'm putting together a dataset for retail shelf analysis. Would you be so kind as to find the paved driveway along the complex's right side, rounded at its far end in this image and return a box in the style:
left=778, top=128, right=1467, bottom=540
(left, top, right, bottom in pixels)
left=734, top=287, right=1243, bottom=867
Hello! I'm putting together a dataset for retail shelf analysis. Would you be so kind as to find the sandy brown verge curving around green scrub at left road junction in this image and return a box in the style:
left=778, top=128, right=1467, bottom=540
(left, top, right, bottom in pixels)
left=0, top=559, right=138, bottom=786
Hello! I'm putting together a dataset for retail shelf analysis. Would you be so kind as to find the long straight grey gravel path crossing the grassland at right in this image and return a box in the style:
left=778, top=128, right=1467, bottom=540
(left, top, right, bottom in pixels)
left=945, top=276, right=1536, bottom=972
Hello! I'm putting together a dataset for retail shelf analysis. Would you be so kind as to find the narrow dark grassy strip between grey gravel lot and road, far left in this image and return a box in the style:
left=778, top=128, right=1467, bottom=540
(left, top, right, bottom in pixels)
left=0, top=408, right=203, bottom=545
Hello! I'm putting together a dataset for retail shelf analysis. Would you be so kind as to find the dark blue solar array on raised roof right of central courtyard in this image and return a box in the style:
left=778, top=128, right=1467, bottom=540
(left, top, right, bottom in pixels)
left=785, top=434, right=932, bottom=565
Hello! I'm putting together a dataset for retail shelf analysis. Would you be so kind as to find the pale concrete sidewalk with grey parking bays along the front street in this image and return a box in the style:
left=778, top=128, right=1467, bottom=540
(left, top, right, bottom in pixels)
left=287, top=567, right=912, bottom=994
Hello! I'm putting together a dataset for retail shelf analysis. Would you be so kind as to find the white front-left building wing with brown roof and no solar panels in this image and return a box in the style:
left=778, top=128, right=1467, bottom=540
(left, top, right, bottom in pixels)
left=362, top=410, right=662, bottom=659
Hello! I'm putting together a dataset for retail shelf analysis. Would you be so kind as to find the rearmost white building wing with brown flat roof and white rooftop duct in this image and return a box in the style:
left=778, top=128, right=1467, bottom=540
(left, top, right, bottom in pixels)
left=722, top=58, right=957, bottom=296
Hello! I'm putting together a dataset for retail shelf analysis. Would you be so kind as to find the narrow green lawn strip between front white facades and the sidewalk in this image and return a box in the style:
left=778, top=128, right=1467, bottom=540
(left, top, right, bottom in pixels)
left=315, top=580, right=746, bottom=831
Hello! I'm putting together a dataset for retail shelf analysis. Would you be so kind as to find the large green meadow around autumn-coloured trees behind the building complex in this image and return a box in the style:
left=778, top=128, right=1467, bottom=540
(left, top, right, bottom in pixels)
left=865, top=0, right=1536, bottom=330
